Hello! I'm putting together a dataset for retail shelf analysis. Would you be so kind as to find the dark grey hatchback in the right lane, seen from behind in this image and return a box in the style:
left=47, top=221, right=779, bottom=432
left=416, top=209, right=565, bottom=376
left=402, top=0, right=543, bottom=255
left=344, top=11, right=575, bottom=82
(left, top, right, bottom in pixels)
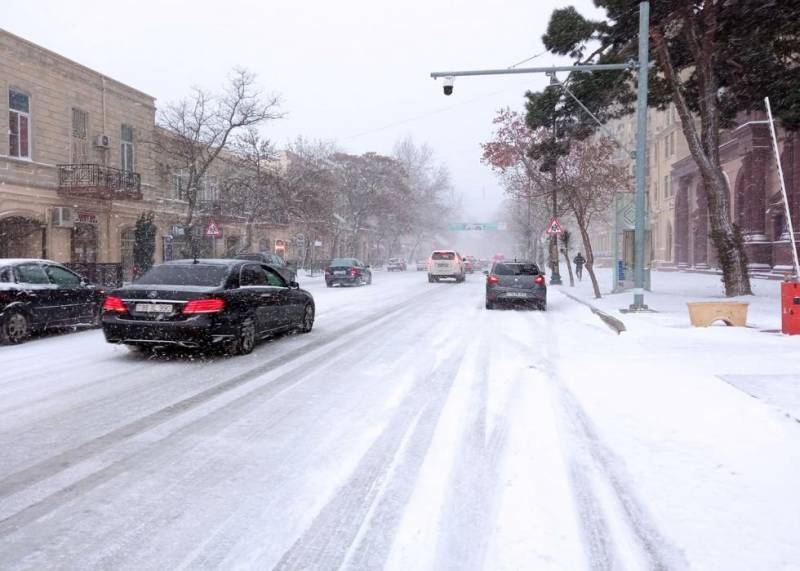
left=486, top=260, right=547, bottom=311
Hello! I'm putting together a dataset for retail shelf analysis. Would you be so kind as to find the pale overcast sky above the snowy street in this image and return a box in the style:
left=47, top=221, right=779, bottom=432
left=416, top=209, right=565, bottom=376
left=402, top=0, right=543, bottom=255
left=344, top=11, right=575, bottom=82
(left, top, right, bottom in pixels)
left=2, top=0, right=597, bottom=221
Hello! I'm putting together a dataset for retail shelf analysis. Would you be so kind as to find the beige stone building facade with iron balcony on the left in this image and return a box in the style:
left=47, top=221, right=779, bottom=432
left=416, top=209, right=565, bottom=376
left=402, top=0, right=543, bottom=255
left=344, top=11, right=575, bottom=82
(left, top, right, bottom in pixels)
left=0, top=30, right=306, bottom=278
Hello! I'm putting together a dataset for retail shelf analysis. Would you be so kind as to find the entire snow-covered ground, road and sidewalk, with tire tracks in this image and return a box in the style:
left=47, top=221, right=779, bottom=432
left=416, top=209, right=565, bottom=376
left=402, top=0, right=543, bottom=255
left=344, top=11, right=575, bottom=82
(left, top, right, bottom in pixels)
left=0, top=271, right=800, bottom=570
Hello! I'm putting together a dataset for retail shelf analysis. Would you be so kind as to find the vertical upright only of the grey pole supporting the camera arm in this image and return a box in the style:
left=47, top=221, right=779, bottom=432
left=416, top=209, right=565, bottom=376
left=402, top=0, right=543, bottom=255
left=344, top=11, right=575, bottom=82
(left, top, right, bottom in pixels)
left=630, top=2, right=650, bottom=311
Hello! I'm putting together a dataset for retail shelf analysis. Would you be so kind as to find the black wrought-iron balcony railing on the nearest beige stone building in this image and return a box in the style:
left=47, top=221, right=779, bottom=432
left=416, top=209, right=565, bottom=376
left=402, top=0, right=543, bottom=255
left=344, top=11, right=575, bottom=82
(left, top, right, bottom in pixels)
left=58, top=164, right=142, bottom=200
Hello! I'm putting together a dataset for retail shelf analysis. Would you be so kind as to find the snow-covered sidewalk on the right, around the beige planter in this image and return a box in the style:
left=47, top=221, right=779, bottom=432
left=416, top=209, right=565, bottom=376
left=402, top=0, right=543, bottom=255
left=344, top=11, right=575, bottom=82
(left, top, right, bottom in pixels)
left=560, top=268, right=800, bottom=419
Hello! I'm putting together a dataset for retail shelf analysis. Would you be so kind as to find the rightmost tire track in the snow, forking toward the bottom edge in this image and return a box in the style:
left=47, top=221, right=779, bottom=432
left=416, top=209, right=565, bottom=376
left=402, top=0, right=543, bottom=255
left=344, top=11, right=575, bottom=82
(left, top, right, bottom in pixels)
left=543, top=302, right=688, bottom=571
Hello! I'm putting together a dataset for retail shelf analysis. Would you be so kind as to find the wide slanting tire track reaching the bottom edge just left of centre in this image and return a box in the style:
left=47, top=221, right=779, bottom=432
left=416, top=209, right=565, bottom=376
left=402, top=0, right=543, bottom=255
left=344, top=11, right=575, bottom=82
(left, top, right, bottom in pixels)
left=274, top=339, right=468, bottom=570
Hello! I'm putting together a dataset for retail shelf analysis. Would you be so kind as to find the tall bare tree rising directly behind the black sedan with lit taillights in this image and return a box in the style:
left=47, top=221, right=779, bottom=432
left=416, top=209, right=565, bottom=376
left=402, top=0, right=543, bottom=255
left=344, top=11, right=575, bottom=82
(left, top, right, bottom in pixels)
left=152, top=69, right=283, bottom=251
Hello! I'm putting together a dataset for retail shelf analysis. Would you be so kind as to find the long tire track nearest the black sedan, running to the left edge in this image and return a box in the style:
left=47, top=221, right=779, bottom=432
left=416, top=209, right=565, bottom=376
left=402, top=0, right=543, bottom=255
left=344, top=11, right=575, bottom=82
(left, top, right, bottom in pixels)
left=0, top=289, right=445, bottom=502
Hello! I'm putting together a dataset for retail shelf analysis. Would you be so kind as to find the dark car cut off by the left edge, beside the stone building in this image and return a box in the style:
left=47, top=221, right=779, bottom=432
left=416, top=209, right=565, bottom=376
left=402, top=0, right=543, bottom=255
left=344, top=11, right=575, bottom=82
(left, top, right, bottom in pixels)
left=0, top=258, right=103, bottom=343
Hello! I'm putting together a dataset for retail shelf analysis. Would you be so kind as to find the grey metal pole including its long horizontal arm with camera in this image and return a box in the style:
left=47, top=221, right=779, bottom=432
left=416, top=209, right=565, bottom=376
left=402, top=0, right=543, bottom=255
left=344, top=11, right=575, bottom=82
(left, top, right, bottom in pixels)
left=431, top=1, right=650, bottom=311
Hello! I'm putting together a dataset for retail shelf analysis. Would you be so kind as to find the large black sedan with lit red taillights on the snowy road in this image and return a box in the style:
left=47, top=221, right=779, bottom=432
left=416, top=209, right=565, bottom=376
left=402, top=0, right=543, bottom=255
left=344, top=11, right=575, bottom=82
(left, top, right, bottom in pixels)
left=102, top=260, right=315, bottom=355
